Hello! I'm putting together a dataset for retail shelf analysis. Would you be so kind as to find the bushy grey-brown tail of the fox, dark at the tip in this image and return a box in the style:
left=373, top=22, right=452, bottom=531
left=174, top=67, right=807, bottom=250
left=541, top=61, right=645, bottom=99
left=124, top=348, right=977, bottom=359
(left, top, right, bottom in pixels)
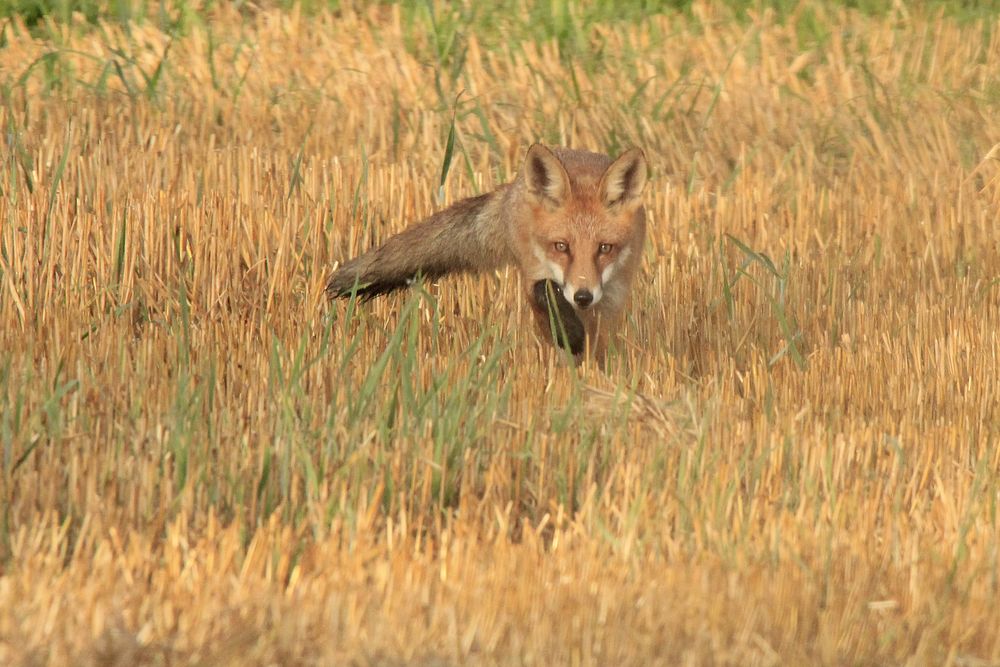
left=326, top=190, right=511, bottom=299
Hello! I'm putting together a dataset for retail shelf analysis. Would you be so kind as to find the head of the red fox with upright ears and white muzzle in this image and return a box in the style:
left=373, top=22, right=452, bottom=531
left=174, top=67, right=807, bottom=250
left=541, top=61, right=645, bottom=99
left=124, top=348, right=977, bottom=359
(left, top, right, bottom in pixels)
left=523, top=144, right=647, bottom=310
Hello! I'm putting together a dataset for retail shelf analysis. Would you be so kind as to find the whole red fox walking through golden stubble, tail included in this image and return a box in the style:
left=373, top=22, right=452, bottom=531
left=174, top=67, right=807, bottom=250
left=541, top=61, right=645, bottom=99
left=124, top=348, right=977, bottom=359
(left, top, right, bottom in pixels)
left=326, top=144, right=647, bottom=361
